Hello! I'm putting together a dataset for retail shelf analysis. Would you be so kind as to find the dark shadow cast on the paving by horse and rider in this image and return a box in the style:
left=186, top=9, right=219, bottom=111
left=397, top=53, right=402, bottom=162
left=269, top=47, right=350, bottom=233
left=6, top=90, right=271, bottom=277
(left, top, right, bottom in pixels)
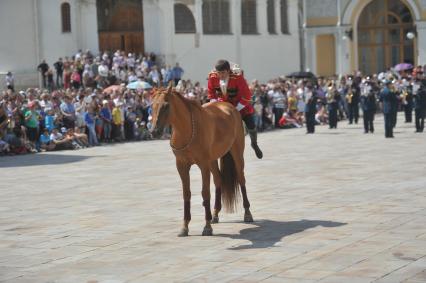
left=215, top=219, right=346, bottom=250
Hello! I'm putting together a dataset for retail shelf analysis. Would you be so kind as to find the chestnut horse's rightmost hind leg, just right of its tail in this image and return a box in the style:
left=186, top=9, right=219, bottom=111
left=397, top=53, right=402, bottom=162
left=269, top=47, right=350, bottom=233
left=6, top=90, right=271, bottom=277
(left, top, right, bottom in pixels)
left=231, top=145, right=253, bottom=223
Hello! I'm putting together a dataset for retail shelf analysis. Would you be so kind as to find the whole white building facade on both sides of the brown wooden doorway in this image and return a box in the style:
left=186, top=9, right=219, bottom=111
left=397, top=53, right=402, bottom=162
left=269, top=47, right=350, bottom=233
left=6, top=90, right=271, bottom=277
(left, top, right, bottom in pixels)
left=0, top=0, right=300, bottom=89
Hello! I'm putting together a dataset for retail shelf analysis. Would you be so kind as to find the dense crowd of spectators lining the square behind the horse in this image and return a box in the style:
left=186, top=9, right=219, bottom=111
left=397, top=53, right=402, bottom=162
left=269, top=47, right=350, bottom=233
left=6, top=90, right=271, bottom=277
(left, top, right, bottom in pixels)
left=0, top=48, right=426, bottom=154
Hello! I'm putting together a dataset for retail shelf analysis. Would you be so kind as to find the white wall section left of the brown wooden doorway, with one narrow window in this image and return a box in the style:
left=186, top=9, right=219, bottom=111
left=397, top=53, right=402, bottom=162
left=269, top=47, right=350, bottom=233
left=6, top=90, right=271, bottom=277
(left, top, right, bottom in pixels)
left=0, top=0, right=98, bottom=87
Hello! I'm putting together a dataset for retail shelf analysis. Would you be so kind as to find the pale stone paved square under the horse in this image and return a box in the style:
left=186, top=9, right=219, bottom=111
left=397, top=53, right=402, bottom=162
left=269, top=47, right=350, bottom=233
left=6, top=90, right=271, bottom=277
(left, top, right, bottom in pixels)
left=0, top=115, right=426, bottom=283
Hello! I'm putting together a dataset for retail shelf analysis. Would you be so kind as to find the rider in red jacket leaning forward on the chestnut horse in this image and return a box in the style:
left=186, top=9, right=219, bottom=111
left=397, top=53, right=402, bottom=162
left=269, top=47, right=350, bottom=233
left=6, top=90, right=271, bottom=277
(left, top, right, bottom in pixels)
left=208, top=60, right=263, bottom=159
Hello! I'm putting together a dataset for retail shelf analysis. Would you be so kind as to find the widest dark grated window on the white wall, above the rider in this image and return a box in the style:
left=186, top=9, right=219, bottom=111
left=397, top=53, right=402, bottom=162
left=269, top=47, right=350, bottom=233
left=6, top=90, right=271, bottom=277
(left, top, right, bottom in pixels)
left=203, top=0, right=231, bottom=34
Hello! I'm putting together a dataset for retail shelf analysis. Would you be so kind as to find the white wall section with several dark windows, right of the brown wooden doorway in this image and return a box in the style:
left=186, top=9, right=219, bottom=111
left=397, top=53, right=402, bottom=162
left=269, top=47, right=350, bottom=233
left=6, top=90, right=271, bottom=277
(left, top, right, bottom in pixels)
left=143, top=0, right=300, bottom=82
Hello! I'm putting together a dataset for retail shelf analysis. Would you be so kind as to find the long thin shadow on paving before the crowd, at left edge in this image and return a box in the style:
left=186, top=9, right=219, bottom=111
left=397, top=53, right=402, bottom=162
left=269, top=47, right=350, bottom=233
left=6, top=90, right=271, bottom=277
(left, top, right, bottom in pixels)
left=0, top=154, right=91, bottom=168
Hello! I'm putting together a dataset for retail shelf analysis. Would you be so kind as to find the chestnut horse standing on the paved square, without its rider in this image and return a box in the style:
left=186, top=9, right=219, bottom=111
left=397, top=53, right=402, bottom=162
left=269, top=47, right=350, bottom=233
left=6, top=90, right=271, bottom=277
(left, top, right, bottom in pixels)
left=152, top=86, right=253, bottom=237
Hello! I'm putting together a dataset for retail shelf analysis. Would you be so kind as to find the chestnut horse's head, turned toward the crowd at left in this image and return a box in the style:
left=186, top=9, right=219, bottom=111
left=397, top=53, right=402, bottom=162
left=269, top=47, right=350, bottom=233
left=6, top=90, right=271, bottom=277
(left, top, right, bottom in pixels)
left=151, top=85, right=172, bottom=138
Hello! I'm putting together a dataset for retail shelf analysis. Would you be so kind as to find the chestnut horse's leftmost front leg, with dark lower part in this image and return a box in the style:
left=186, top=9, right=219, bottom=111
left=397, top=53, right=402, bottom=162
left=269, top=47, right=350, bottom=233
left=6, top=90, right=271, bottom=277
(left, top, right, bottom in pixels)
left=176, top=160, right=191, bottom=237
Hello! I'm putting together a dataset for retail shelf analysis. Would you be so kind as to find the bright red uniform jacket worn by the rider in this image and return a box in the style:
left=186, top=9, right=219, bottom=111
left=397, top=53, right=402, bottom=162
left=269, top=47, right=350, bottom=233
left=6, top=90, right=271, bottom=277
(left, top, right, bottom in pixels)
left=207, top=72, right=254, bottom=117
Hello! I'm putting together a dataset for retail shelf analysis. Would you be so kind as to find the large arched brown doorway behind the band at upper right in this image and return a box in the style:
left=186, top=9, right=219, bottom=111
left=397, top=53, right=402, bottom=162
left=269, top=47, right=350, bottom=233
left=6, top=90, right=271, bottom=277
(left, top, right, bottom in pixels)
left=357, top=0, right=415, bottom=74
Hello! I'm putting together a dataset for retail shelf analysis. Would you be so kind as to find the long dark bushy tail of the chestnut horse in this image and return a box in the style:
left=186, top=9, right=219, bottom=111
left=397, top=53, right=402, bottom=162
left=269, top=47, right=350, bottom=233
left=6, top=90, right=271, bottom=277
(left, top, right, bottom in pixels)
left=220, top=151, right=239, bottom=213
